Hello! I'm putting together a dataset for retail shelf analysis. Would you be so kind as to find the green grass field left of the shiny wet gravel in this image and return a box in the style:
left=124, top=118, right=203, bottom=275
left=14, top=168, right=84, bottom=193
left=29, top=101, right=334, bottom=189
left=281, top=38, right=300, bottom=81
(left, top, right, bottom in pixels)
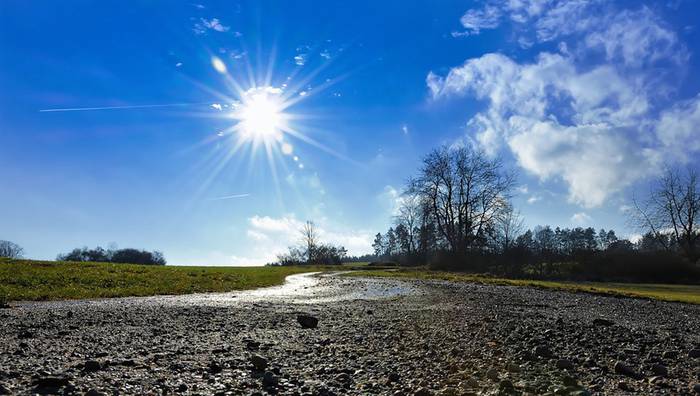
left=0, top=259, right=327, bottom=302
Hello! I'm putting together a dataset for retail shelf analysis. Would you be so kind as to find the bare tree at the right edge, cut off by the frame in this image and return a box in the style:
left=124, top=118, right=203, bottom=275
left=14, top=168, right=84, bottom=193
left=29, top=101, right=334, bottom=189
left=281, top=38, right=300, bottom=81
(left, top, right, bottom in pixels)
left=634, top=169, right=700, bottom=261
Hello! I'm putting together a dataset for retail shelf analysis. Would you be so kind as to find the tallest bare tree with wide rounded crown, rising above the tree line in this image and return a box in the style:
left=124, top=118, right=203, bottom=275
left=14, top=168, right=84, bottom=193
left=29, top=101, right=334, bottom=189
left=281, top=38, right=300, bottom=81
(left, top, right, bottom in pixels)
left=409, top=146, right=513, bottom=253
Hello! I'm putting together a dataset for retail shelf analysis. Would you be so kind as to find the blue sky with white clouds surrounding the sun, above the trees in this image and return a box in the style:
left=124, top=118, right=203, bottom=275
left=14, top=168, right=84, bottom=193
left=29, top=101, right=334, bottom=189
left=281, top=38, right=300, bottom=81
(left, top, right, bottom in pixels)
left=0, top=0, right=700, bottom=265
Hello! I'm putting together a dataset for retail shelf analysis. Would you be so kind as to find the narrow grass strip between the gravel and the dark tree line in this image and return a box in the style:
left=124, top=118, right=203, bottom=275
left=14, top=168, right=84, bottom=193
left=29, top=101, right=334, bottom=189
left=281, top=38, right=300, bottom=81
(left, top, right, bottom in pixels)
left=348, top=269, right=700, bottom=304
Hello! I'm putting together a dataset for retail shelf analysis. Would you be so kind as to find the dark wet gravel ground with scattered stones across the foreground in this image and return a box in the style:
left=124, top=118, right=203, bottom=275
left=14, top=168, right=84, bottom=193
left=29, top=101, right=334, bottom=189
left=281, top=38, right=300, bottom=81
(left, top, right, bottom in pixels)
left=0, top=276, right=700, bottom=395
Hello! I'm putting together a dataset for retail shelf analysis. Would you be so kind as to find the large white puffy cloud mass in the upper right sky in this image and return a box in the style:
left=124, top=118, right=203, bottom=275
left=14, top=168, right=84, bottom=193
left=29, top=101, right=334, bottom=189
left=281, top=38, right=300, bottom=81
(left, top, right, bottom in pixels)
left=426, top=0, right=700, bottom=207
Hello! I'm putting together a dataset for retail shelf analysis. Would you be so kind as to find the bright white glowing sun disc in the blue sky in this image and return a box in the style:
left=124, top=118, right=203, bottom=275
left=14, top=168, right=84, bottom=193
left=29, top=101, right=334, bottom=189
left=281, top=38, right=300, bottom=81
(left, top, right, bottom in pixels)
left=232, top=87, right=288, bottom=143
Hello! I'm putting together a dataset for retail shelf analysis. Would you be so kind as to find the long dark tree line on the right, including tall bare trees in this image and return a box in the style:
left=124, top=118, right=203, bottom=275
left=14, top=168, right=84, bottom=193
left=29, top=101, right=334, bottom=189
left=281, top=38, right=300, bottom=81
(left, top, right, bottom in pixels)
left=372, top=146, right=700, bottom=281
